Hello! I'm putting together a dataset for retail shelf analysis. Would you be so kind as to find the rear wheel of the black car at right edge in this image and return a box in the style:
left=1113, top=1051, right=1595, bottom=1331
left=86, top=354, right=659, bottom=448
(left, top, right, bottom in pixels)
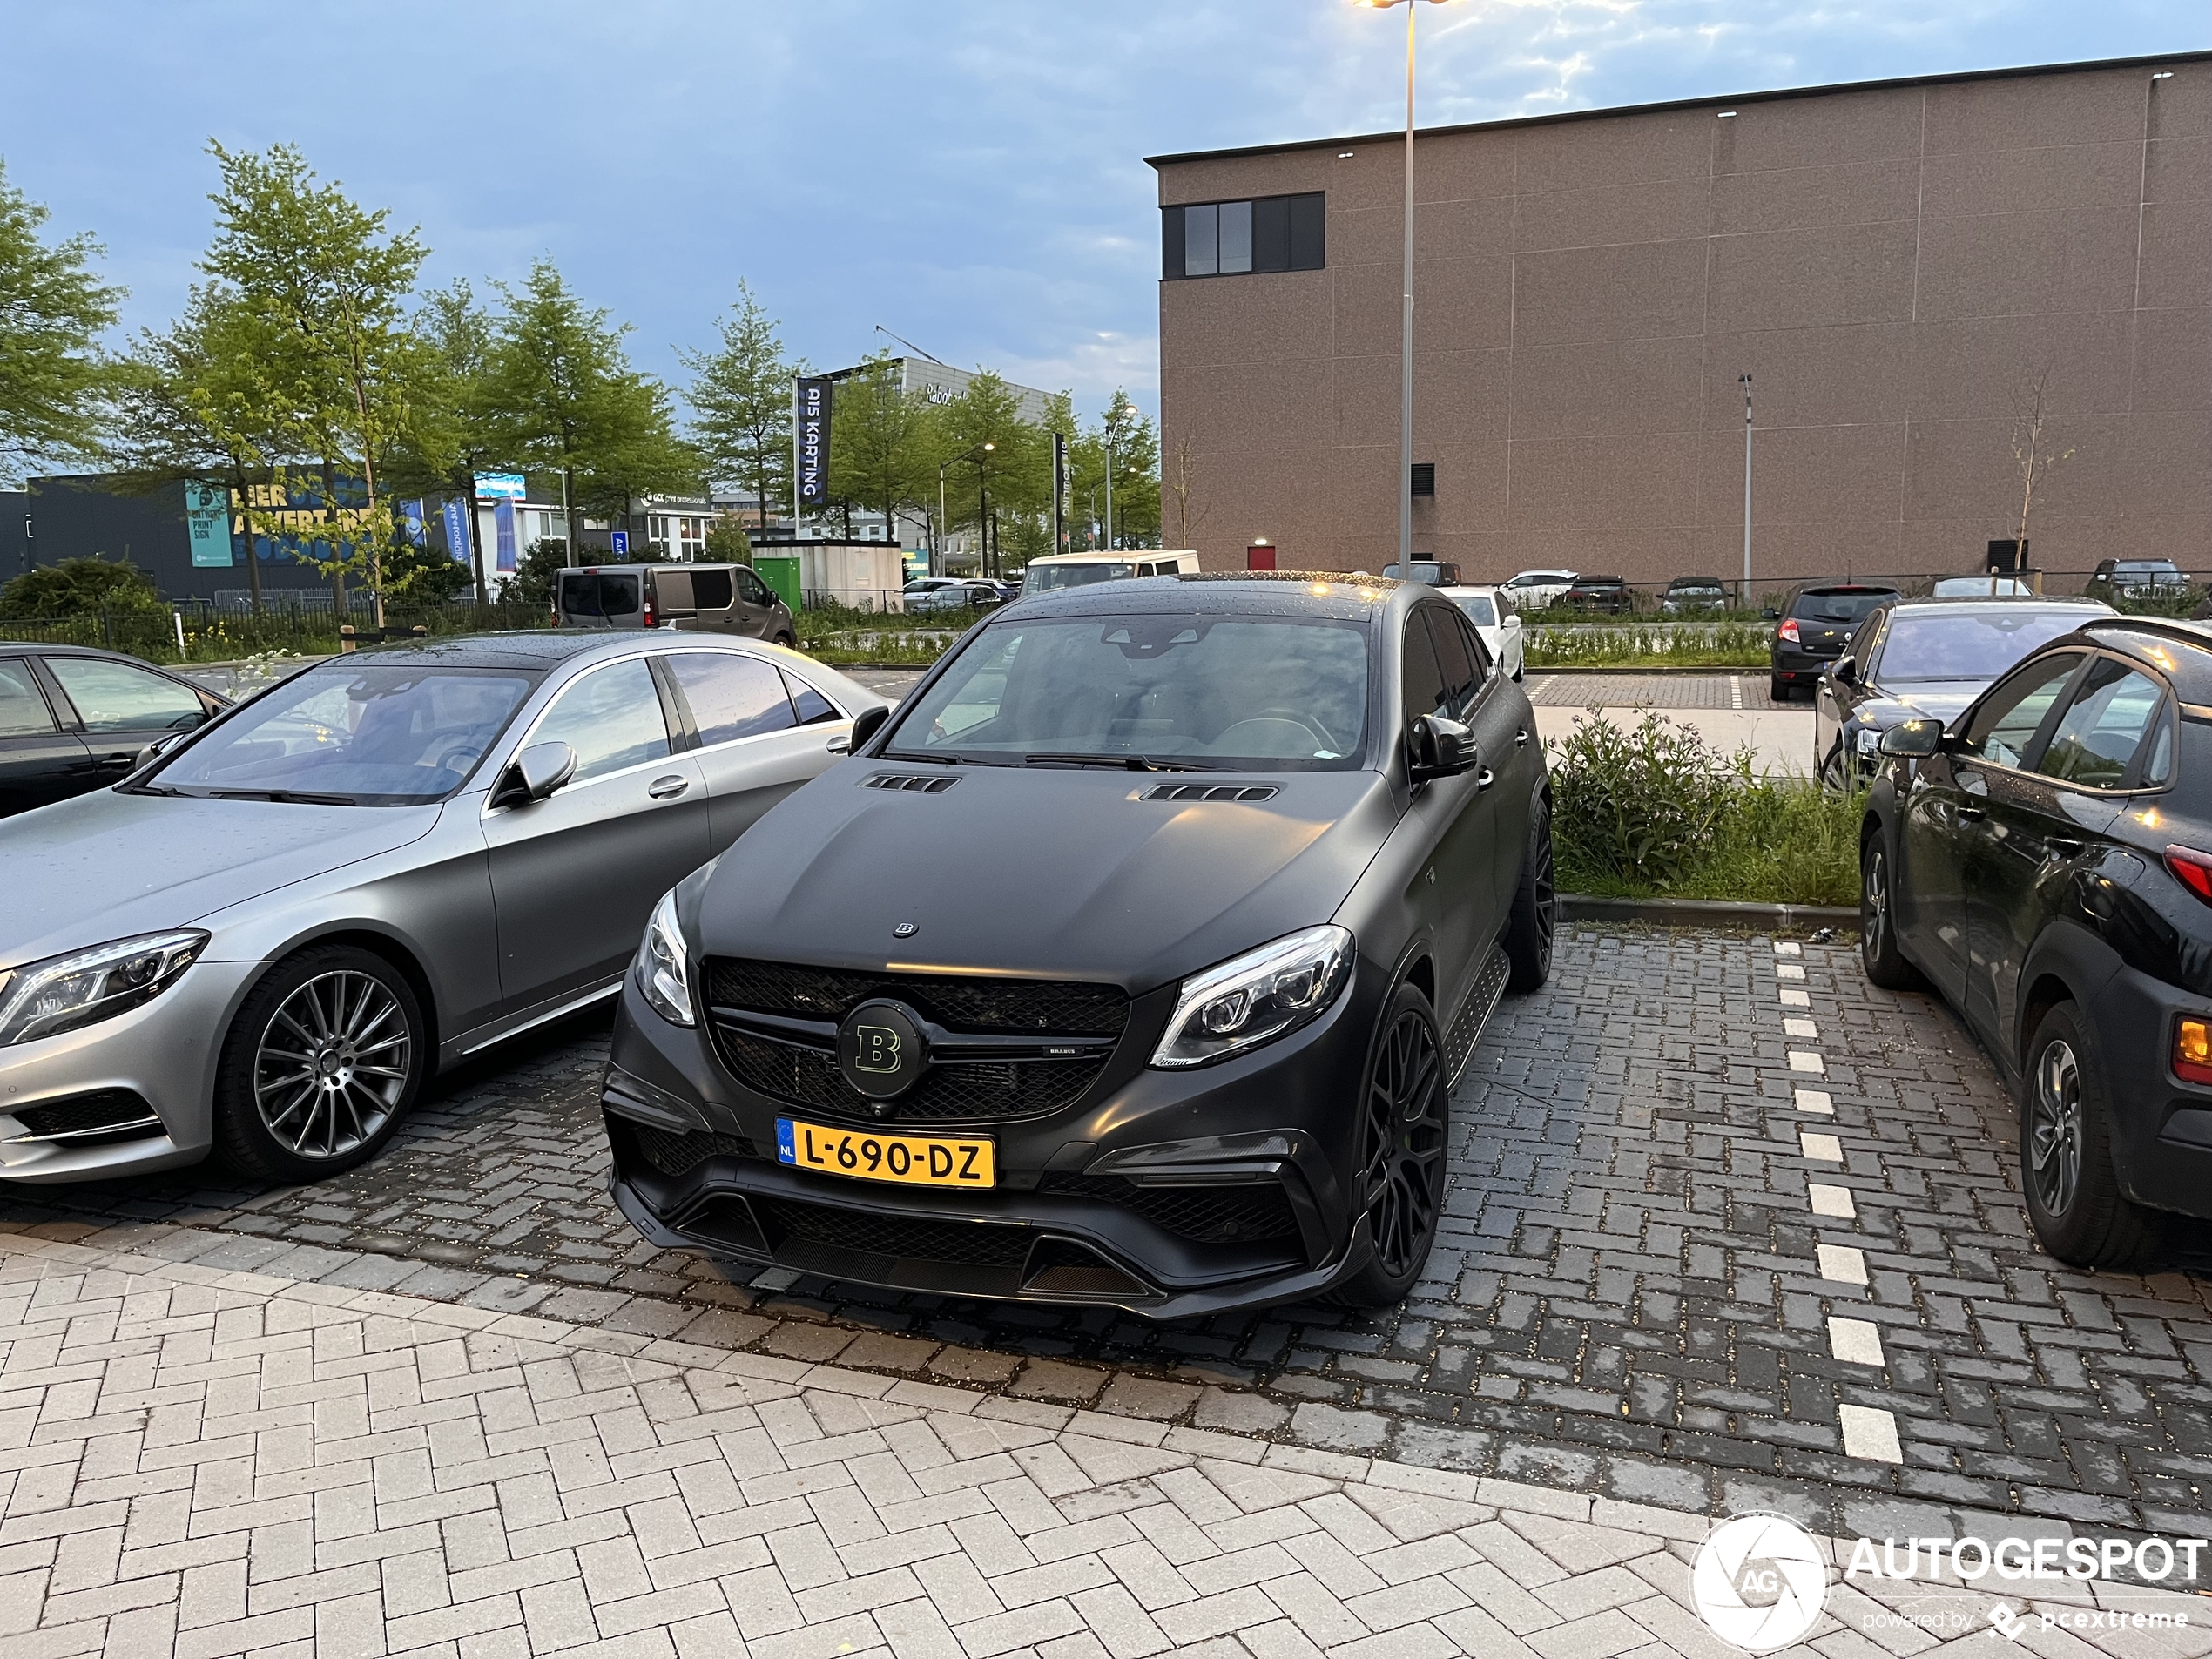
left=2020, top=1002, right=2166, bottom=1267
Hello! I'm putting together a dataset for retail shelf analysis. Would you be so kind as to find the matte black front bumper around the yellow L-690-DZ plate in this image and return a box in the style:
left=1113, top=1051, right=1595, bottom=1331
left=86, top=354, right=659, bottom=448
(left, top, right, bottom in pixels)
left=602, top=962, right=1387, bottom=1318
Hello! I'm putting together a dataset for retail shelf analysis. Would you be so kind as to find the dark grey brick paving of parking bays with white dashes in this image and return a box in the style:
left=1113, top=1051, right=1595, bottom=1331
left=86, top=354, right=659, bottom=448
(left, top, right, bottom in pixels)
left=12, top=927, right=2212, bottom=1535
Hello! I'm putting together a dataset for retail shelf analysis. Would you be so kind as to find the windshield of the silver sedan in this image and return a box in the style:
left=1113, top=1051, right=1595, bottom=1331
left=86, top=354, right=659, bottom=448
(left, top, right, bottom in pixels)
left=148, top=657, right=536, bottom=807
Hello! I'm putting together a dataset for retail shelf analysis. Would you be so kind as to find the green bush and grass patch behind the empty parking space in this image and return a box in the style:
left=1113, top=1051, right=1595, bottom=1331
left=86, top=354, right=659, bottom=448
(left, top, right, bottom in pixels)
left=1551, top=714, right=1865, bottom=905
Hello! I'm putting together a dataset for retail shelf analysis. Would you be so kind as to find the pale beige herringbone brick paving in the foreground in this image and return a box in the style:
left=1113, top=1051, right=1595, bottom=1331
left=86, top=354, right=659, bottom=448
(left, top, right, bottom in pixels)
left=0, top=1234, right=2212, bottom=1659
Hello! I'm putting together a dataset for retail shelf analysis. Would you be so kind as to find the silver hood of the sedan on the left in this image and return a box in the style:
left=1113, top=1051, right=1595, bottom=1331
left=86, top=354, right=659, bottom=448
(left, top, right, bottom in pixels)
left=0, top=790, right=442, bottom=967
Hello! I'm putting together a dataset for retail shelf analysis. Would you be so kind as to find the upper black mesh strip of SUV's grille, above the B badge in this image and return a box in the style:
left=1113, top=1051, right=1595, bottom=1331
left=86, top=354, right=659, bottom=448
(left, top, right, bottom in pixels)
left=705, top=958, right=1128, bottom=1037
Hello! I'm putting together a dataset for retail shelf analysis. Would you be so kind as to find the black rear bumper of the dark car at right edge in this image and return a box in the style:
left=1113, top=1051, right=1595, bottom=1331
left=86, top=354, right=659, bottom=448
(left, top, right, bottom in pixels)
left=2088, top=964, right=2212, bottom=1219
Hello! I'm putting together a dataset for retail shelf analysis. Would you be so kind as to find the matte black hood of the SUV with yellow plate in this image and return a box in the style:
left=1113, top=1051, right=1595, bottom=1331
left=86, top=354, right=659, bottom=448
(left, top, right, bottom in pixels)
left=699, top=759, right=1398, bottom=993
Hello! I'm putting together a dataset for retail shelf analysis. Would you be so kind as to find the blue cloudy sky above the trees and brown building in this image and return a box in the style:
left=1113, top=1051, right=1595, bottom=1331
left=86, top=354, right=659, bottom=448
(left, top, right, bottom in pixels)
left=0, top=0, right=2212, bottom=428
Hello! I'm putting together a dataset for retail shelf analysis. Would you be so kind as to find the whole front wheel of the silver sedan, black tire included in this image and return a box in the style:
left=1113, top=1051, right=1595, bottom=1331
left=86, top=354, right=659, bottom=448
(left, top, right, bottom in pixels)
left=214, top=945, right=429, bottom=1181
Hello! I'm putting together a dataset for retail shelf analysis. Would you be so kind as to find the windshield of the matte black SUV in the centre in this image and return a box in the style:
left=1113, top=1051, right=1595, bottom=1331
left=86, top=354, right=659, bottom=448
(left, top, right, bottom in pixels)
left=887, top=615, right=1367, bottom=770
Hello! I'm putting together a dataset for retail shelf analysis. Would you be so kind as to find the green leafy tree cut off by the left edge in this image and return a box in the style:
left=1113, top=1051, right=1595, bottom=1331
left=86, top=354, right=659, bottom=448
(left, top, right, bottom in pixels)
left=0, top=164, right=124, bottom=482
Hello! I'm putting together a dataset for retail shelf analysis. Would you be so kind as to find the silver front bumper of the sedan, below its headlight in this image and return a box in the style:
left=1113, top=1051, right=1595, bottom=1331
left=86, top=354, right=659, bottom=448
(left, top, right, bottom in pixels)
left=0, top=958, right=261, bottom=1181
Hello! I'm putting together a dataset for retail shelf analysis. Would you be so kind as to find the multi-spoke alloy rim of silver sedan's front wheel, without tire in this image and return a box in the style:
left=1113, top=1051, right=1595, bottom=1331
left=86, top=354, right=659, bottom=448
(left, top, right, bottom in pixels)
left=254, top=969, right=414, bottom=1159
